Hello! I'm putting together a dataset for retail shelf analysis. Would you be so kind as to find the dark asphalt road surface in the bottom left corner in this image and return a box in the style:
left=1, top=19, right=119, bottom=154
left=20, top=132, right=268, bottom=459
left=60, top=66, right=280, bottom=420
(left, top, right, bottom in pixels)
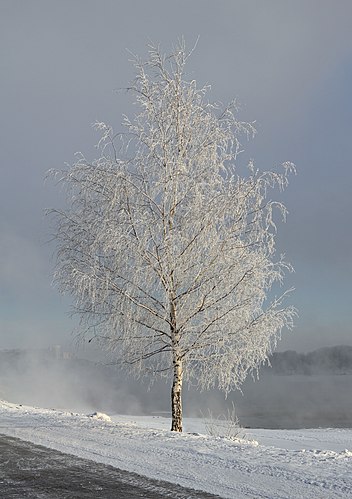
left=0, top=435, right=219, bottom=499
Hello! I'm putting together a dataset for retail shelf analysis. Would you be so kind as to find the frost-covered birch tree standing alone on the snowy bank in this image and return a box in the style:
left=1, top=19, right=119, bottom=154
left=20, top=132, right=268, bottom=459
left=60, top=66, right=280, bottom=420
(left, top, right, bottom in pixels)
left=52, top=44, right=295, bottom=431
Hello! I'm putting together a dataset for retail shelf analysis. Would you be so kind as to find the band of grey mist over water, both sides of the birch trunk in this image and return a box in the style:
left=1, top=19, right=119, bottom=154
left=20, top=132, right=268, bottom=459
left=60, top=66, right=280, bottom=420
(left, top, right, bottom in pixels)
left=0, top=347, right=352, bottom=428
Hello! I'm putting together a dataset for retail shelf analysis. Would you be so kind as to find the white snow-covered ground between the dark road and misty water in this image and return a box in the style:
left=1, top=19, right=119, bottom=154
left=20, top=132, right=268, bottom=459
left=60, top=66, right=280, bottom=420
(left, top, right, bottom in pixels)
left=0, top=401, right=352, bottom=499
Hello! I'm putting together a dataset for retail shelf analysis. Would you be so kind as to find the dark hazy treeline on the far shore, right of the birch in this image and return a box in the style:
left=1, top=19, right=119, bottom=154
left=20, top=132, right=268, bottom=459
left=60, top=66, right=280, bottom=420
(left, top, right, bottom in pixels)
left=265, top=345, right=352, bottom=375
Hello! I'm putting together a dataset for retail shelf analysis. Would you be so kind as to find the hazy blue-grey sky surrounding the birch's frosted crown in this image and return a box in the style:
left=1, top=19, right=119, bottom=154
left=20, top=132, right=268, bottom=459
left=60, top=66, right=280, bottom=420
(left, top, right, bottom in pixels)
left=0, top=0, right=352, bottom=352
